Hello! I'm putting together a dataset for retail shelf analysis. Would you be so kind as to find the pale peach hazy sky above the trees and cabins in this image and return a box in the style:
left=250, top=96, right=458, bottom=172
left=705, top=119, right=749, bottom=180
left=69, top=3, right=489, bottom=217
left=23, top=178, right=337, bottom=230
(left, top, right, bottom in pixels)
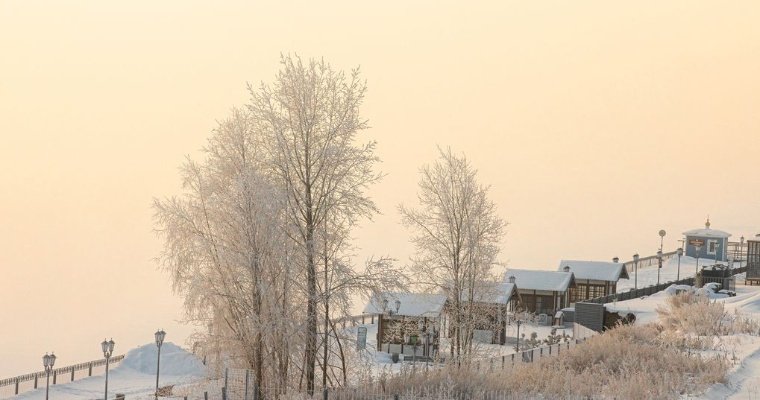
left=0, top=0, right=760, bottom=377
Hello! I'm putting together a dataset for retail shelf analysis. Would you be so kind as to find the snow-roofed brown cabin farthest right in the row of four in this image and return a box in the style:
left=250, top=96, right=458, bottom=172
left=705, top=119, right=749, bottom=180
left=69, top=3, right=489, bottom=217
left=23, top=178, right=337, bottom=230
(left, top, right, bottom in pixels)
left=558, top=260, right=629, bottom=304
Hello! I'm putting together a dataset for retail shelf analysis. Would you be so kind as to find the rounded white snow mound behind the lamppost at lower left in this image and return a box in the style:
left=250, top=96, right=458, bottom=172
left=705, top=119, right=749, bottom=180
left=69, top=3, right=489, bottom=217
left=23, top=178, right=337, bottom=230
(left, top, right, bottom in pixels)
left=117, top=342, right=206, bottom=376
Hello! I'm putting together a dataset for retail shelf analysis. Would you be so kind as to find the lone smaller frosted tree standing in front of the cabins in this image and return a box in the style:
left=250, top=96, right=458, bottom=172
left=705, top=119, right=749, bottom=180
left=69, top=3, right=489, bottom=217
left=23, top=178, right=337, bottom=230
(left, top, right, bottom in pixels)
left=399, top=148, right=505, bottom=359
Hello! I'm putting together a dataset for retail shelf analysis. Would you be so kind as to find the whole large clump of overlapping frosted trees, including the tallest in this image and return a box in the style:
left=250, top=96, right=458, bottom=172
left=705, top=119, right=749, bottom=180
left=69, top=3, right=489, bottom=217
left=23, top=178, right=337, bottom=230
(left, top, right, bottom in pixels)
left=154, top=57, right=404, bottom=393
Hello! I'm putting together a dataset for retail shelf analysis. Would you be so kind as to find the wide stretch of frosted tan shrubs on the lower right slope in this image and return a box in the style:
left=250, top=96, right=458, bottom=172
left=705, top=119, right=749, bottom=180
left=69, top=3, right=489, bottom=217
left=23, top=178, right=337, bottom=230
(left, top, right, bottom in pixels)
left=356, top=324, right=728, bottom=400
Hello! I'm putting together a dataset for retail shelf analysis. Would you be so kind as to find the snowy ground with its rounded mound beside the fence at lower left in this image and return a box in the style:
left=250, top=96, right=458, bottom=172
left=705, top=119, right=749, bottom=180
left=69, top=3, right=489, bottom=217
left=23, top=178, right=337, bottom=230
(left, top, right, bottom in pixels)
left=9, top=342, right=206, bottom=400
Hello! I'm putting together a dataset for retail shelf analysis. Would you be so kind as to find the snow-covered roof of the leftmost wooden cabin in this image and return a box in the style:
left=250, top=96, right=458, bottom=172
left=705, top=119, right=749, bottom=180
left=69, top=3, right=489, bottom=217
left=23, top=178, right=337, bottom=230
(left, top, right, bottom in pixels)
left=362, top=292, right=446, bottom=317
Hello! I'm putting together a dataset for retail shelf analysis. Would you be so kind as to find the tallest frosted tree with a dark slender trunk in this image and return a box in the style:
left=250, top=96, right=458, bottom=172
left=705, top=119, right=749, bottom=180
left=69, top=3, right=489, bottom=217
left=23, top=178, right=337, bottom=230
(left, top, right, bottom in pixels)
left=249, top=56, right=379, bottom=393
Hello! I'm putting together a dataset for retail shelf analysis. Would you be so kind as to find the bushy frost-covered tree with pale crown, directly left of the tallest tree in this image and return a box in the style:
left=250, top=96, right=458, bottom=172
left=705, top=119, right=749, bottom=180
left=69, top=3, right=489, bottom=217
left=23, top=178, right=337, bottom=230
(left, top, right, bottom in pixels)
left=154, top=109, right=299, bottom=396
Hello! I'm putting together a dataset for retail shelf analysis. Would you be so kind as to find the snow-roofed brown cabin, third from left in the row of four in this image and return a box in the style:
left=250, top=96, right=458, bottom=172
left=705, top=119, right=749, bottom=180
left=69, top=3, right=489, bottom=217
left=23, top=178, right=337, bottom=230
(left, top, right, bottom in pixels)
left=504, top=269, right=575, bottom=317
